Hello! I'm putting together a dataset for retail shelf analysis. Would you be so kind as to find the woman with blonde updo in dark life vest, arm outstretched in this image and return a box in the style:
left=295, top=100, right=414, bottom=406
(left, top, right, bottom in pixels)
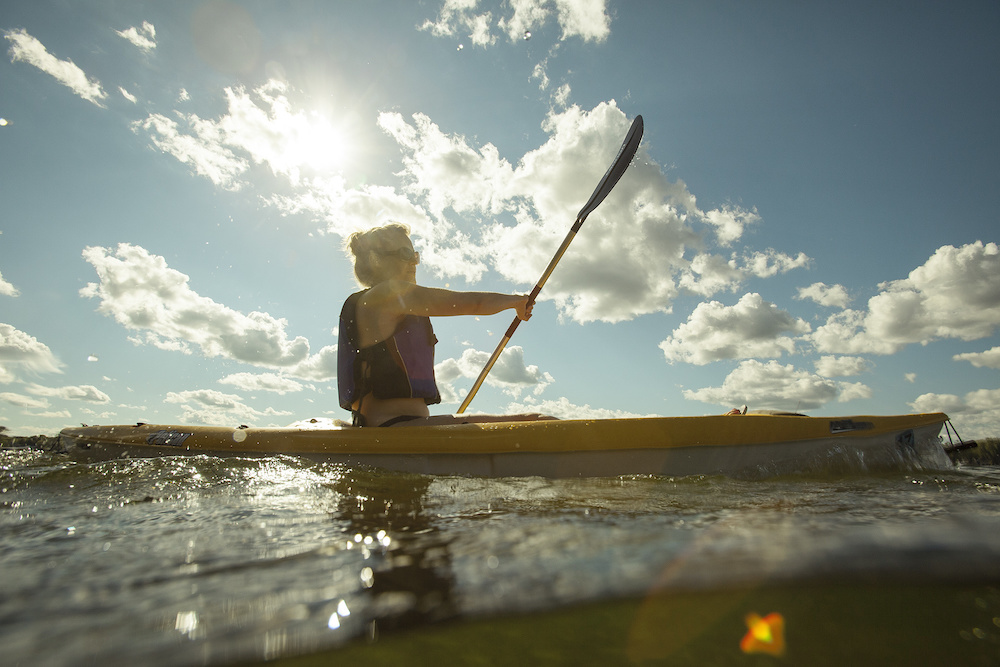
left=337, top=223, right=539, bottom=426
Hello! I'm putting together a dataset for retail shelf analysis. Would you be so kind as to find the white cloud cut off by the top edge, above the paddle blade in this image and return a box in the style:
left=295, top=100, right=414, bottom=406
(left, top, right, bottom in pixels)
left=419, top=0, right=611, bottom=47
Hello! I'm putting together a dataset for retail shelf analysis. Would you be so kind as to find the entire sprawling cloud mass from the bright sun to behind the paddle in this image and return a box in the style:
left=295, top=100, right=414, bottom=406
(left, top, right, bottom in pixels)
left=133, top=86, right=810, bottom=322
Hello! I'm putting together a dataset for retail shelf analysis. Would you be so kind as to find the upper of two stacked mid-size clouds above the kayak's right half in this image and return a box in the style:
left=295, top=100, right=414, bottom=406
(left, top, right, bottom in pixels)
left=660, top=294, right=809, bottom=366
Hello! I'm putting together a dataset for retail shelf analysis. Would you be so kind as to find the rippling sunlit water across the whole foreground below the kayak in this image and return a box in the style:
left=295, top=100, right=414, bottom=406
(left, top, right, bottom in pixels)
left=0, top=449, right=1000, bottom=666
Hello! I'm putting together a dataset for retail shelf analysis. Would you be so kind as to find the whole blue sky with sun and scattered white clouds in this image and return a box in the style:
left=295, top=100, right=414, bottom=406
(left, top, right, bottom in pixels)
left=0, top=0, right=1000, bottom=438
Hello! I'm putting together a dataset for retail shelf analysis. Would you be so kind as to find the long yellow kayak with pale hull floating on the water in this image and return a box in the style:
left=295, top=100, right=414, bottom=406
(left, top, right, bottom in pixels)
left=59, top=413, right=950, bottom=478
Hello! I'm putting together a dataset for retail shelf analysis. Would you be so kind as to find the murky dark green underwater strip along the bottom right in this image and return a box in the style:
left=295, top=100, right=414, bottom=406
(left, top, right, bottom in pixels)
left=268, top=583, right=1000, bottom=667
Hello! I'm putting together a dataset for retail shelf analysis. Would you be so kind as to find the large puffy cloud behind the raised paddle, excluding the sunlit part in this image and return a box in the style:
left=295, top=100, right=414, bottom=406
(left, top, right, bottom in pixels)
left=380, top=102, right=784, bottom=322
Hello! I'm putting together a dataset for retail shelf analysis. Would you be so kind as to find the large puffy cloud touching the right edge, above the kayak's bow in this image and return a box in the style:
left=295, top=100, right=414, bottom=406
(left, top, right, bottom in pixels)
left=813, top=241, right=1000, bottom=354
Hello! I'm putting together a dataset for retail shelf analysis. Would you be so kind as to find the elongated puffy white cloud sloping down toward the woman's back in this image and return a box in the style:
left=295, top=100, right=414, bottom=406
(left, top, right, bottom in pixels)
left=80, top=243, right=336, bottom=379
